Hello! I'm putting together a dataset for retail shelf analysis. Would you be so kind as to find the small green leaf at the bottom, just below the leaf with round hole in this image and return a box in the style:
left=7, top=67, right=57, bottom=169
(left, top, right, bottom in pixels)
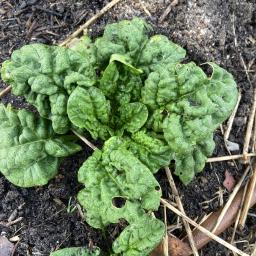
left=113, top=216, right=165, bottom=256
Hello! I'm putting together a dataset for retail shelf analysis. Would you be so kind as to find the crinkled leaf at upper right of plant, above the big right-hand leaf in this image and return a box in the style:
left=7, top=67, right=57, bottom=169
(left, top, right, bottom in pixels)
left=138, top=35, right=186, bottom=73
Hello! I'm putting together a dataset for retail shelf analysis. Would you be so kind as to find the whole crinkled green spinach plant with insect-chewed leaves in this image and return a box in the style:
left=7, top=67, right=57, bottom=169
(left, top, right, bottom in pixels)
left=0, top=18, right=238, bottom=256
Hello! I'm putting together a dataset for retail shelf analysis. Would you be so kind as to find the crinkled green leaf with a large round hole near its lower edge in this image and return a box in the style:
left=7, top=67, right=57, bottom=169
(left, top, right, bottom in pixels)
left=78, top=137, right=161, bottom=228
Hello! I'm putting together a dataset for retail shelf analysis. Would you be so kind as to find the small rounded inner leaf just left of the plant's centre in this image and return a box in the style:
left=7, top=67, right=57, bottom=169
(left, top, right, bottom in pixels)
left=67, top=87, right=110, bottom=139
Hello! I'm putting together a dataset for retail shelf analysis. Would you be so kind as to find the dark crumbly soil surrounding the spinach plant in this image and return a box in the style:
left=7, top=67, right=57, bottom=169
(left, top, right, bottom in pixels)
left=0, top=0, right=256, bottom=256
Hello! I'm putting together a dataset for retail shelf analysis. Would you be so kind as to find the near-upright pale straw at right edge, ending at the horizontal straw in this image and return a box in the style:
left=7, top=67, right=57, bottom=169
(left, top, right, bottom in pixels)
left=243, top=89, right=256, bottom=163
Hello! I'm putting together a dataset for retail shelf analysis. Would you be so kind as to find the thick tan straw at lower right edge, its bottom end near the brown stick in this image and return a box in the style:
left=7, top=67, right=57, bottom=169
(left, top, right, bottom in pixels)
left=239, top=163, right=256, bottom=229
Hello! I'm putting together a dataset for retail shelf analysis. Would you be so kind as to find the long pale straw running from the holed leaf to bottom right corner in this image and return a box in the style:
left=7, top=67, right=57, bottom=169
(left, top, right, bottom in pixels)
left=161, top=198, right=249, bottom=256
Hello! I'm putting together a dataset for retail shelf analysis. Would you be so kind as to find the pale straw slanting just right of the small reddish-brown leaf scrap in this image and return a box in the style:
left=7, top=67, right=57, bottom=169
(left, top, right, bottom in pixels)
left=212, top=166, right=251, bottom=233
